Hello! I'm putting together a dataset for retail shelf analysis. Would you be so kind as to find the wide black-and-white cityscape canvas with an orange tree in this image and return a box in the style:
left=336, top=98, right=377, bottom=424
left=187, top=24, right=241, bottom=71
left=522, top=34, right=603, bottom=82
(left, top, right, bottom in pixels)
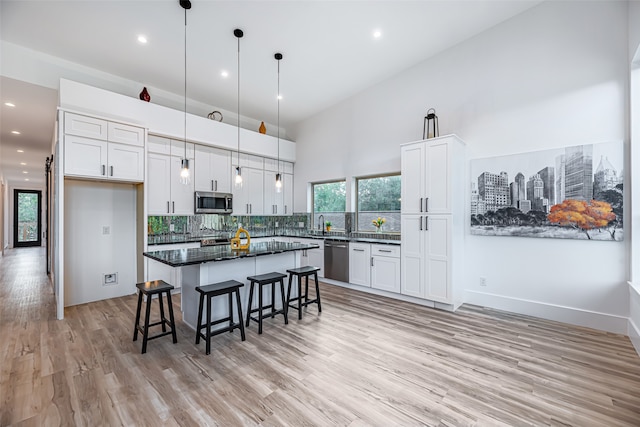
left=471, top=142, right=624, bottom=241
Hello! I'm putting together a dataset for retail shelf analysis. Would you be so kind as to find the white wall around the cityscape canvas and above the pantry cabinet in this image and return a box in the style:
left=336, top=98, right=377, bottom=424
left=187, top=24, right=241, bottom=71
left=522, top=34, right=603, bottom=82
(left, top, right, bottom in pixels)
left=293, top=2, right=629, bottom=333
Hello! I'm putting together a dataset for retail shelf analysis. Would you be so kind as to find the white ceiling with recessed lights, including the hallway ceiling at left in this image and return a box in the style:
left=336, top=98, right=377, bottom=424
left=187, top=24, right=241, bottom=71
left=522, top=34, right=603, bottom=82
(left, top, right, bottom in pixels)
left=0, top=0, right=540, bottom=187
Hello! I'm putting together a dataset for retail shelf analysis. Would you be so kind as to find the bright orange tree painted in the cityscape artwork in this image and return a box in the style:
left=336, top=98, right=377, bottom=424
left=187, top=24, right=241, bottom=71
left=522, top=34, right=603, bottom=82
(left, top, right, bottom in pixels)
left=547, top=199, right=616, bottom=240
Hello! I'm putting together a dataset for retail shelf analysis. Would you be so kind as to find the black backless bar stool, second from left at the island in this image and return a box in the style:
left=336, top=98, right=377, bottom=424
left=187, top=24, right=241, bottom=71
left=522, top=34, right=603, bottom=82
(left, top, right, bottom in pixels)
left=196, top=280, right=245, bottom=354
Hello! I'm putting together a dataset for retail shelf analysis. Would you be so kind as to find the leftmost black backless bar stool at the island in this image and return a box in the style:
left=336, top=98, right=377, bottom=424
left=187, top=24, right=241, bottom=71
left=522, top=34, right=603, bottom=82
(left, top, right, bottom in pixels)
left=133, top=280, right=178, bottom=354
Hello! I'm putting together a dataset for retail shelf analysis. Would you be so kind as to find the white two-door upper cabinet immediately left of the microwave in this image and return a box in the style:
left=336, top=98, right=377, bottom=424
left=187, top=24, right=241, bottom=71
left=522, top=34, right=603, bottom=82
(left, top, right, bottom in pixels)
left=146, top=141, right=196, bottom=215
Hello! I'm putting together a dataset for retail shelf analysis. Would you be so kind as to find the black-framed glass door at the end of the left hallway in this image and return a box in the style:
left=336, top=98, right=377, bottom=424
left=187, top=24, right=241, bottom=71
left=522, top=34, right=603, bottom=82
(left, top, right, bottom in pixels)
left=13, top=190, right=42, bottom=248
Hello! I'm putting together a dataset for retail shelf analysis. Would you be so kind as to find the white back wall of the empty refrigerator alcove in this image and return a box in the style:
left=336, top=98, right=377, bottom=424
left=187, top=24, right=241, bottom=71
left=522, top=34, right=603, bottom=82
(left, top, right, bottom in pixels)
left=64, top=179, right=137, bottom=306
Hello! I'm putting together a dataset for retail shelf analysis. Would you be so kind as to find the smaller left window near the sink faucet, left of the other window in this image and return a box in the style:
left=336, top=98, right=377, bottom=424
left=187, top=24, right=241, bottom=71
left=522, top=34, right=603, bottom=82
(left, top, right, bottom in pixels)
left=312, top=181, right=347, bottom=230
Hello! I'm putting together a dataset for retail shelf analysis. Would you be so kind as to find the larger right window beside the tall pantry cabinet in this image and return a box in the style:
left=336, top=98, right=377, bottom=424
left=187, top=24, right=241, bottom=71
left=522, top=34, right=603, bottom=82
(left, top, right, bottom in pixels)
left=356, top=174, right=400, bottom=233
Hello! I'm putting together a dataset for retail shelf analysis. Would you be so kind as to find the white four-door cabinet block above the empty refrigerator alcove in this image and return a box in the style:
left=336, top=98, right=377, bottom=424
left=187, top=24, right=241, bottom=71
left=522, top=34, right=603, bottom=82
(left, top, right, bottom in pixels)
left=64, top=112, right=145, bottom=182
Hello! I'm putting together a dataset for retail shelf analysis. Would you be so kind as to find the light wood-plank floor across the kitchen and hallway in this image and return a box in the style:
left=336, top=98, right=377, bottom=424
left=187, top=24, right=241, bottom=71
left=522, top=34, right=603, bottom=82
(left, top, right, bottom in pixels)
left=0, top=248, right=640, bottom=426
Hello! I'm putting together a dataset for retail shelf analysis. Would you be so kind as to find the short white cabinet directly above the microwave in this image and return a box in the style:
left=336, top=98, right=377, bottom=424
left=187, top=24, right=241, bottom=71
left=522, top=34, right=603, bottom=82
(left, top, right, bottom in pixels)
left=194, top=144, right=231, bottom=193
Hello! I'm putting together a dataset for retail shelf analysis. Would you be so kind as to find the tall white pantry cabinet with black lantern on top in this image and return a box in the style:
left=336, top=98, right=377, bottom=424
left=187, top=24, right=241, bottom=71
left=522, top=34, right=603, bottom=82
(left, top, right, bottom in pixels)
left=400, top=135, right=467, bottom=310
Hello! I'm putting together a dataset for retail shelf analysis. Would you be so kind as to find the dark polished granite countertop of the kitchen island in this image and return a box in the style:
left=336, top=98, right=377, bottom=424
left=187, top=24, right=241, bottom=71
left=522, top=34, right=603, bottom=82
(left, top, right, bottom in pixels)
left=144, top=241, right=319, bottom=267
